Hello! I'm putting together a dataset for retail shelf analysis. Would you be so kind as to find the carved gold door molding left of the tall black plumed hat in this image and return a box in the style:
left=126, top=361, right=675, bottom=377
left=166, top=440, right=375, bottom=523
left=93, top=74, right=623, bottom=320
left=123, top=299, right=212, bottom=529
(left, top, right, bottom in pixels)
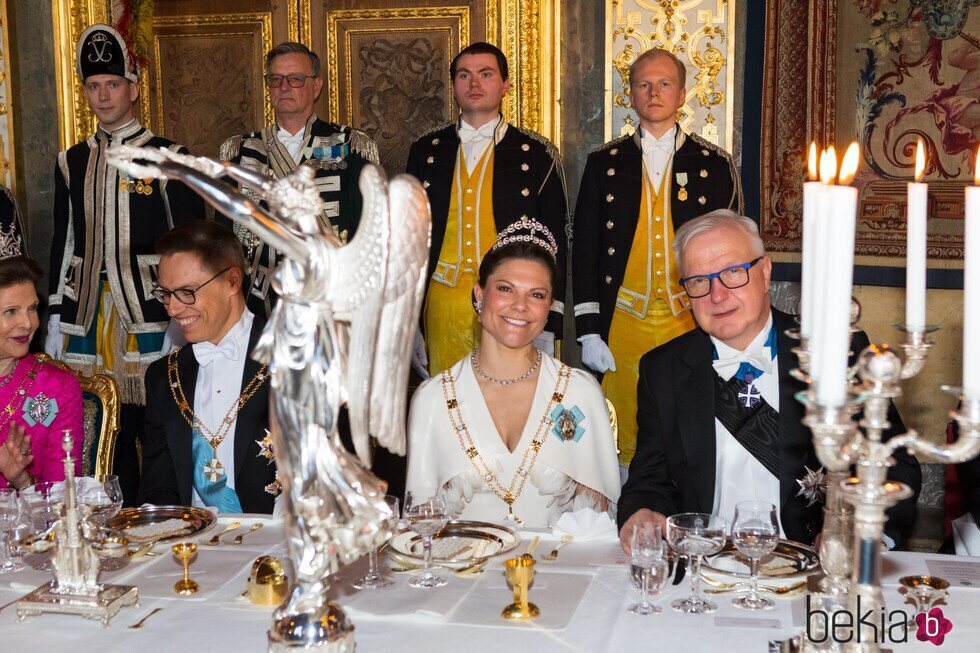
left=51, top=0, right=112, bottom=149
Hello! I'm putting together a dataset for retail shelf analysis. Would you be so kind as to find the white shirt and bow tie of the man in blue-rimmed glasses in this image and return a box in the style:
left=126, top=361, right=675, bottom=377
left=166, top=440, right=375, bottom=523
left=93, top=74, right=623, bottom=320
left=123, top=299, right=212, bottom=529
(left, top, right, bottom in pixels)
left=711, top=312, right=783, bottom=535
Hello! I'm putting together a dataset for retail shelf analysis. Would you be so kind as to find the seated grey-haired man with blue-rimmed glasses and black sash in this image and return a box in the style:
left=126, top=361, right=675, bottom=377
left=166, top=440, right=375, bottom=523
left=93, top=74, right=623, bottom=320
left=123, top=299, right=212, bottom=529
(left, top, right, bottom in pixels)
left=618, top=209, right=922, bottom=549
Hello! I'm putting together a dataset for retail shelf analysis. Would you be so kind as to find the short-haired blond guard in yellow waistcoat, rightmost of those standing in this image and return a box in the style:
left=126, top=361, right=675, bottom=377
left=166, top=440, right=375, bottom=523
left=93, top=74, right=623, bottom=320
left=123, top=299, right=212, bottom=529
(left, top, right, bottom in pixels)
left=572, top=48, right=743, bottom=465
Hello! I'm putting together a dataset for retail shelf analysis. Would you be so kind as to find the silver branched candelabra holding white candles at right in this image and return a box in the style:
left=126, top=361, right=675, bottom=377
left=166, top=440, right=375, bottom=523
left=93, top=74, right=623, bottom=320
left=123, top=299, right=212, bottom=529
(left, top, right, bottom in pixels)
left=790, top=325, right=980, bottom=653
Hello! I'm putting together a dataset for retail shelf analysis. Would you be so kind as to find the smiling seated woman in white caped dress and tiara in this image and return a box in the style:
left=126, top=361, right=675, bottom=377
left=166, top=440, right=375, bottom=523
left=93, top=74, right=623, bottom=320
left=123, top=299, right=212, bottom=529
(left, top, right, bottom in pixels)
left=406, top=220, right=619, bottom=528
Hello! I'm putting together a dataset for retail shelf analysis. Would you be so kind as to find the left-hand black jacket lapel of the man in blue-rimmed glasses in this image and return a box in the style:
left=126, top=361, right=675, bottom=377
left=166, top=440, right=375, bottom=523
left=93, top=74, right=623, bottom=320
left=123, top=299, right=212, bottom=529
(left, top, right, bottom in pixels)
left=674, top=332, right=716, bottom=513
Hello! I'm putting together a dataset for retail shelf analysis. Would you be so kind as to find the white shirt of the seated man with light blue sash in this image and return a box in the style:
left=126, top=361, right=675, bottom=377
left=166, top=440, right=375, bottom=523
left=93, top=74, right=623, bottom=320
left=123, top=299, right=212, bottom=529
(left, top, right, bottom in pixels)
left=191, top=308, right=255, bottom=507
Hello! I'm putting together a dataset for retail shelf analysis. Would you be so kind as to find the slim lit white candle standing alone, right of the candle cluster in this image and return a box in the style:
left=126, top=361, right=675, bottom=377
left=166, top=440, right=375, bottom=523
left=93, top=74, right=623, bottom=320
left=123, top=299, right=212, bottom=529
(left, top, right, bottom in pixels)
left=905, top=138, right=929, bottom=329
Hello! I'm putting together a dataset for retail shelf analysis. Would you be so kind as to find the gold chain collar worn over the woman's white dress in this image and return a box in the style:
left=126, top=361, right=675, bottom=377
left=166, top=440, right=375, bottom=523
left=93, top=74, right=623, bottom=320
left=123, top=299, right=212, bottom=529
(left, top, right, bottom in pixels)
left=440, top=363, right=572, bottom=524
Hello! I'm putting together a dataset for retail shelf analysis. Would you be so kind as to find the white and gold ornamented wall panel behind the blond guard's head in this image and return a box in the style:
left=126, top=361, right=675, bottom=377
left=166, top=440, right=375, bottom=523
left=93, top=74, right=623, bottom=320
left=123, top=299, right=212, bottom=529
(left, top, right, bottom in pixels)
left=605, top=0, right=738, bottom=152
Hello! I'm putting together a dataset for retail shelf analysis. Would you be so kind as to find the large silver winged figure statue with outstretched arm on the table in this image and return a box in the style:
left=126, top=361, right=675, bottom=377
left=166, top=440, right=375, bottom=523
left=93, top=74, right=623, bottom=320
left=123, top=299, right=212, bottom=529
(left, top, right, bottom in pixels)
left=109, top=146, right=430, bottom=651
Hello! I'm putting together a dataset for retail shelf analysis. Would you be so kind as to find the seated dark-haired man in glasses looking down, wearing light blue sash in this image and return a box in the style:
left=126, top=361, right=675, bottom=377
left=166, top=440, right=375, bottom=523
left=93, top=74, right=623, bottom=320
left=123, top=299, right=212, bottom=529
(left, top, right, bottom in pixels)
left=140, top=221, right=279, bottom=513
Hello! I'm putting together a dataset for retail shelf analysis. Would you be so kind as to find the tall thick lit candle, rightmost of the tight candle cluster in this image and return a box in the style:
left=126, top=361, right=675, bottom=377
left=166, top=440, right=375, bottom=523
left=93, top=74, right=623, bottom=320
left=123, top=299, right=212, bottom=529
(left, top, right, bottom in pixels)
left=817, top=143, right=859, bottom=406
